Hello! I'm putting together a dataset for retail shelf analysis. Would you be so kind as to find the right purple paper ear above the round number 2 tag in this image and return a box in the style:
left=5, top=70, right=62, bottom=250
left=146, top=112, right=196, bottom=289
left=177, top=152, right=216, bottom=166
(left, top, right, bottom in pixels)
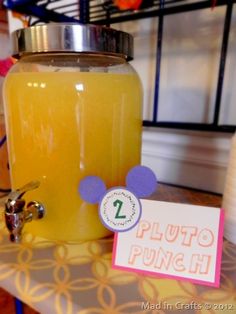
left=126, top=166, right=157, bottom=197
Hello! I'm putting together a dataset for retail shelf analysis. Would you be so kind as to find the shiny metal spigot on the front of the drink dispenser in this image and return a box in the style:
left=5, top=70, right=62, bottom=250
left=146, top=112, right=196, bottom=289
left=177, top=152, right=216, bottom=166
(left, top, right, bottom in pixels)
left=5, top=181, right=45, bottom=243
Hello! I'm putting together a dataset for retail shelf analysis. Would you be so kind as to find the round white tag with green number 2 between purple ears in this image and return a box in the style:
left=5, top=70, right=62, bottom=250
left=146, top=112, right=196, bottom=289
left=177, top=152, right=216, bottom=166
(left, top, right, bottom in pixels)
left=99, top=188, right=142, bottom=232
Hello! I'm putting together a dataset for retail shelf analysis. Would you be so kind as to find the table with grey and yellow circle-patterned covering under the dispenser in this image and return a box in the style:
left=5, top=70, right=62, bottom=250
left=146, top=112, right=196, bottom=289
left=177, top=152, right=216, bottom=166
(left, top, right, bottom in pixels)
left=0, top=184, right=236, bottom=314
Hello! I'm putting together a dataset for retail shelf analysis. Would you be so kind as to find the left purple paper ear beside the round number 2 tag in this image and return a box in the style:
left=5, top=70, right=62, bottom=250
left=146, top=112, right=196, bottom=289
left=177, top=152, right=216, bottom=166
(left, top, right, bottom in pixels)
left=79, top=176, right=107, bottom=204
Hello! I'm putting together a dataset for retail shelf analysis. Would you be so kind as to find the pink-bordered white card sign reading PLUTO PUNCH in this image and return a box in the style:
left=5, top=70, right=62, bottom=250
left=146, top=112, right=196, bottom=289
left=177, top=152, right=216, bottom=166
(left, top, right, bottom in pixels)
left=112, top=200, right=224, bottom=287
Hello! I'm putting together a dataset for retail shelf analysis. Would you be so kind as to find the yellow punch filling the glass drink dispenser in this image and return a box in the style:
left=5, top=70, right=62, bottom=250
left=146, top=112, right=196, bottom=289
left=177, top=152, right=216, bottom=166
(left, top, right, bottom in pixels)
left=5, top=72, right=141, bottom=240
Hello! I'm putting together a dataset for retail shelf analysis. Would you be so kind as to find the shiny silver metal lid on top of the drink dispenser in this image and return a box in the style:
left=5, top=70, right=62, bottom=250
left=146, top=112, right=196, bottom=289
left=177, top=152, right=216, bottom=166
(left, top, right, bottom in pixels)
left=12, top=23, right=133, bottom=61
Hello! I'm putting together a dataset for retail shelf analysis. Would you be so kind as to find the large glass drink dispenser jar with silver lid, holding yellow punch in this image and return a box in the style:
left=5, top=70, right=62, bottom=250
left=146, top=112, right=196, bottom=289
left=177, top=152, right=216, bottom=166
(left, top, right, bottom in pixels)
left=4, top=24, right=142, bottom=241
